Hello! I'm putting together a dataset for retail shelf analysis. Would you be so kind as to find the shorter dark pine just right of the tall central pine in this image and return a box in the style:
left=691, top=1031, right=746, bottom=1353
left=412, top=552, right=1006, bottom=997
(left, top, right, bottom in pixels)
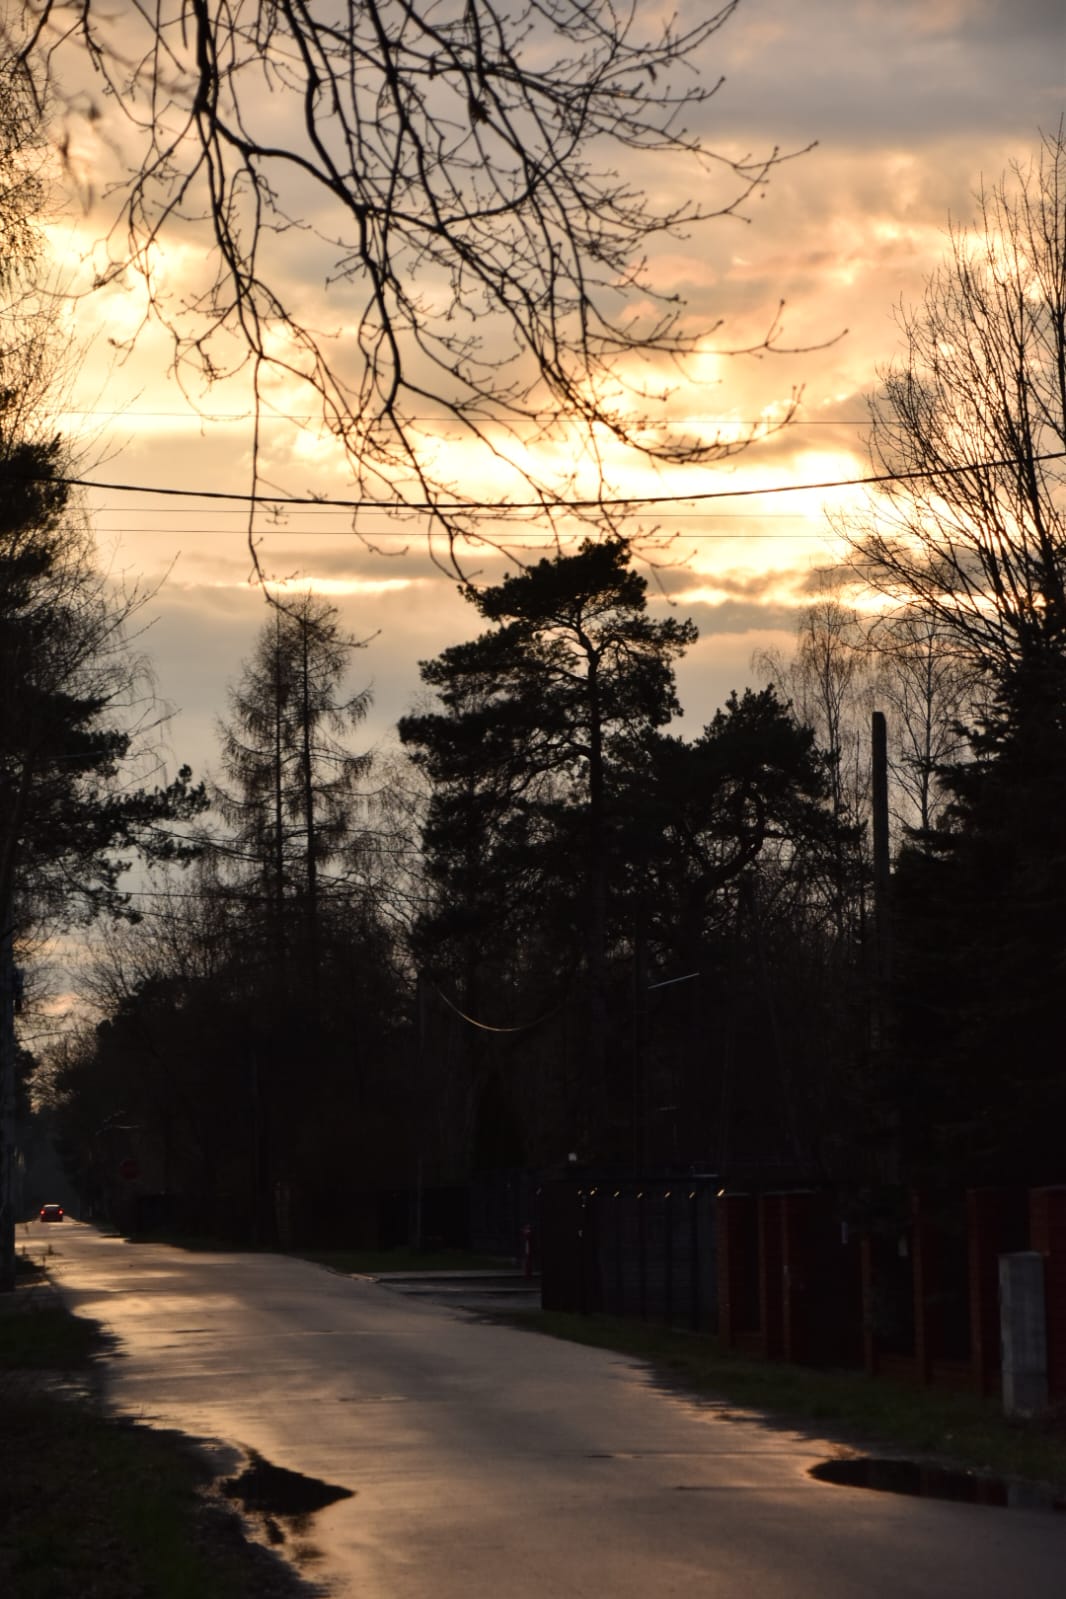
left=626, top=688, right=863, bottom=1178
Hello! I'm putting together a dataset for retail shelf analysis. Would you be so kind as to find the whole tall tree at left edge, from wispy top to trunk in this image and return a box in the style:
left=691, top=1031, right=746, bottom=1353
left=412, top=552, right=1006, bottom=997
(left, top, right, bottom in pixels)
left=0, top=81, right=203, bottom=1289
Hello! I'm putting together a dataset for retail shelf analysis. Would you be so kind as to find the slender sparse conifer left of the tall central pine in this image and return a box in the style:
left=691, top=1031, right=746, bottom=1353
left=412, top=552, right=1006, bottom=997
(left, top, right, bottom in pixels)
left=216, top=593, right=379, bottom=1228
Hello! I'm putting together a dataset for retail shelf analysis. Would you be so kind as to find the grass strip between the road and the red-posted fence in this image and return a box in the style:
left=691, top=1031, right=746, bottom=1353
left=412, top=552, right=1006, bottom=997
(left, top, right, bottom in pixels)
left=494, top=1311, right=1066, bottom=1490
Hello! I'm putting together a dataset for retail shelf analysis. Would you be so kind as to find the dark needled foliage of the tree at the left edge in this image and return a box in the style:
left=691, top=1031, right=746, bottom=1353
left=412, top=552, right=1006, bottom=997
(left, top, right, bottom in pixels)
left=0, top=445, right=205, bottom=923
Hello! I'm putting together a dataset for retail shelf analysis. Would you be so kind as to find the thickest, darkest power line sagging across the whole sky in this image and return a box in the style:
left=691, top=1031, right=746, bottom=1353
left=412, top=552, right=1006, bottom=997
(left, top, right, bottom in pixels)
left=27, top=449, right=1066, bottom=516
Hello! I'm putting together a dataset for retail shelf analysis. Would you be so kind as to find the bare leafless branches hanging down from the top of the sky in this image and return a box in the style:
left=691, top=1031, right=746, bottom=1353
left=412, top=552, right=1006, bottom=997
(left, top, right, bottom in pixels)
left=6, top=0, right=818, bottom=564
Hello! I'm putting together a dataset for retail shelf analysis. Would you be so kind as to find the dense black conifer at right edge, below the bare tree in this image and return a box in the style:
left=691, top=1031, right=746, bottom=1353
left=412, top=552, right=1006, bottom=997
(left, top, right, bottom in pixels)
left=895, top=660, right=1066, bottom=1183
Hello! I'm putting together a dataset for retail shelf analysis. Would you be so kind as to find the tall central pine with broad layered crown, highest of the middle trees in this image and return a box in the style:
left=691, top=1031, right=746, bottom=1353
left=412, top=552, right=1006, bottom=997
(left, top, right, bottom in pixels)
left=400, top=540, right=695, bottom=1138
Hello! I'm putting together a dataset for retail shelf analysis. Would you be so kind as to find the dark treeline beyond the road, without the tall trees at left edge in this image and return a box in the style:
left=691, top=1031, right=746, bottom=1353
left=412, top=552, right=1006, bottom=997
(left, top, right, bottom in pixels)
left=39, top=505, right=1063, bottom=1242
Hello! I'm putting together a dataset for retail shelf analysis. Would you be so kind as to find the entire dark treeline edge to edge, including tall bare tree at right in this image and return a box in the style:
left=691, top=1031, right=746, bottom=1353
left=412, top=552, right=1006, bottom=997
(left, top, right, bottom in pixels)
left=8, top=103, right=1066, bottom=1242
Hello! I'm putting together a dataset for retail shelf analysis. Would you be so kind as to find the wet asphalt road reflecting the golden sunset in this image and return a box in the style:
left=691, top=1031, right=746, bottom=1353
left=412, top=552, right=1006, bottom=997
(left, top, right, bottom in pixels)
left=29, top=1222, right=1066, bottom=1599
